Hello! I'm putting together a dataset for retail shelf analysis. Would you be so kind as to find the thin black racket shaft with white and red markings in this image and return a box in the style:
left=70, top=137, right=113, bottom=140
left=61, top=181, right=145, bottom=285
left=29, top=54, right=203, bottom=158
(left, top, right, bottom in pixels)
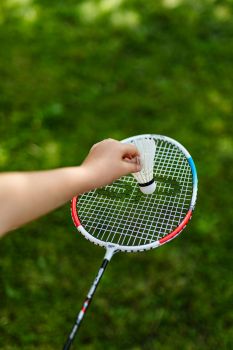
left=63, top=259, right=109, bottom=350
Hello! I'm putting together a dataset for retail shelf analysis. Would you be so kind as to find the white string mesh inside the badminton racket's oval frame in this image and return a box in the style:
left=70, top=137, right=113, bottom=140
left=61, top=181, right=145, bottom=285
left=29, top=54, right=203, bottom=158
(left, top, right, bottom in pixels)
left=77, top=140, right=192, bottom=245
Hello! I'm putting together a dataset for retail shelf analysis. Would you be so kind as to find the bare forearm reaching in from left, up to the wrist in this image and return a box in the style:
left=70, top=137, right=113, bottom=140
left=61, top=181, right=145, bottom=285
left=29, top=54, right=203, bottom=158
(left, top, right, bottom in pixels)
left=0, top=167, right=92, bottom=235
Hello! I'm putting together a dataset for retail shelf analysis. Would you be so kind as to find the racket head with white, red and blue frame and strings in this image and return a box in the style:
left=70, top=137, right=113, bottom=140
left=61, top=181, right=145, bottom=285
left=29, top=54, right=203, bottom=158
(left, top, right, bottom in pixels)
left=71, top=134, right=198, bottom=252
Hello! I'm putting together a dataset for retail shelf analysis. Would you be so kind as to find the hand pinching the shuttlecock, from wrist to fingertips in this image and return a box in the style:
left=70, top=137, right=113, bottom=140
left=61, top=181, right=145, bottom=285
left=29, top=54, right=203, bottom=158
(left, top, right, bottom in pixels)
left=81, top=139, right=141, bottom=189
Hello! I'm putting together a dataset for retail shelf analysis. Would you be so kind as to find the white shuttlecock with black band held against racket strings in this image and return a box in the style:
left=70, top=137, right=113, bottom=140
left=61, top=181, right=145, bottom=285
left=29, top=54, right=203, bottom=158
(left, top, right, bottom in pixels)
left=132, top=138, right=156, bottom=194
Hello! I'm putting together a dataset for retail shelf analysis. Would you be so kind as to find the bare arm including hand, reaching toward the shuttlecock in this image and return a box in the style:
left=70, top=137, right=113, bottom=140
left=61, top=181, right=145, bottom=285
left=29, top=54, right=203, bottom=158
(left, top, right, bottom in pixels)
left=0, top=139, right=140, bottom=236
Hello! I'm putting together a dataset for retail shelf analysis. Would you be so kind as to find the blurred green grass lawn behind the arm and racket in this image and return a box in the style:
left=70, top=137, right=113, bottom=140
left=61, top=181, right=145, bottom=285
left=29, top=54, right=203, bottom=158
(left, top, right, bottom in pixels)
left=0, top=0, right=233, bottom=350
